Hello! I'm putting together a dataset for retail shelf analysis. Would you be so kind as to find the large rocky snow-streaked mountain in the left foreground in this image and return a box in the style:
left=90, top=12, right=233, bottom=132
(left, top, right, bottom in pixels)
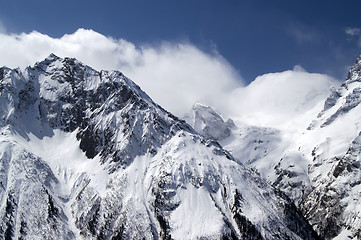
left=0, top=54, right=318, bottom=239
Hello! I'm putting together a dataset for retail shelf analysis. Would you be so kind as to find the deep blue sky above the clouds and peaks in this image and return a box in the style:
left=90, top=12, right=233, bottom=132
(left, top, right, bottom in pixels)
left=0, top=0, right=361, bottom=83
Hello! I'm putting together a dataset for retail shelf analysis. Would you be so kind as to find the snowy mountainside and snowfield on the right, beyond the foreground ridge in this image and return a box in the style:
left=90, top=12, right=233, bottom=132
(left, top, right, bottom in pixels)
left=188, top=57, right=361, bottom=239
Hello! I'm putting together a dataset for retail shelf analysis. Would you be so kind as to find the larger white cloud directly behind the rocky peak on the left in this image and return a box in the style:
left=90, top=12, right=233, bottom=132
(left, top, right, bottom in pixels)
left=0, top=29, right=242, bottom=116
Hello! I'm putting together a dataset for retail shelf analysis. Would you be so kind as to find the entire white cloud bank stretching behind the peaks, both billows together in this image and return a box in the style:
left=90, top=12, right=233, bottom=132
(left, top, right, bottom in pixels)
left=0, top=29, right=335, bottom=126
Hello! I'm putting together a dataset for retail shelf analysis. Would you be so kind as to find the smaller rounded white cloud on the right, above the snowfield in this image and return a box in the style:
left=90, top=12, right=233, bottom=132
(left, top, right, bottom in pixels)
left=229, top=68, right=339, bottom=129
